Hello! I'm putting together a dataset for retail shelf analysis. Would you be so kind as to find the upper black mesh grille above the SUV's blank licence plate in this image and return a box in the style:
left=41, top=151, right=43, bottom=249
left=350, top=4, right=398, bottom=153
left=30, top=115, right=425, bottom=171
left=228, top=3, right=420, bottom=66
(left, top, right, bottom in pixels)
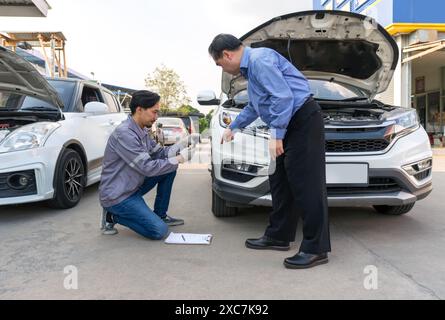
left=326, top=139, right=389, bottom=152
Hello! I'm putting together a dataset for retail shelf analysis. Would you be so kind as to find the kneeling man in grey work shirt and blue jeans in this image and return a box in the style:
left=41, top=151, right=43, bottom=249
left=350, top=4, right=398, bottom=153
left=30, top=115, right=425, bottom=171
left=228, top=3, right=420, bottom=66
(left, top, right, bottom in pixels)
left=99, top=90, right=194, bottom=240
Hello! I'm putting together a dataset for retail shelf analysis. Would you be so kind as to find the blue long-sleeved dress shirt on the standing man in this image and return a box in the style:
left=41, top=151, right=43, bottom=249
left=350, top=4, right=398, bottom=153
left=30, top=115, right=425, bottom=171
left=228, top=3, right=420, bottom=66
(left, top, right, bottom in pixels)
left=229, top=47, right=311, bottom=140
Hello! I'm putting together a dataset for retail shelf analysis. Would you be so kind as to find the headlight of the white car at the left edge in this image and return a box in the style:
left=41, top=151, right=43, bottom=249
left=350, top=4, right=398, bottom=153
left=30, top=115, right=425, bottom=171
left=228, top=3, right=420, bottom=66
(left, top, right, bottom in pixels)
left=0, top=122, right=60, bottom=153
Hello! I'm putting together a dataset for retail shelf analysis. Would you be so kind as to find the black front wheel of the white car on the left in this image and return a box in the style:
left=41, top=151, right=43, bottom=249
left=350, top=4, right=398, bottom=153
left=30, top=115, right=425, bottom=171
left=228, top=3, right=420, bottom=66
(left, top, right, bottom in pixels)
left=48, top=149, right=86, bottom=209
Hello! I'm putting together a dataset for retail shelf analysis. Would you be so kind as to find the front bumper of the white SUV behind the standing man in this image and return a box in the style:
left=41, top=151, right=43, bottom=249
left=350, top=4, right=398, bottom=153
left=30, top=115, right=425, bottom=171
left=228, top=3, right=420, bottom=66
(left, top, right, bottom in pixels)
left=213, top=129, right=432, bottom=207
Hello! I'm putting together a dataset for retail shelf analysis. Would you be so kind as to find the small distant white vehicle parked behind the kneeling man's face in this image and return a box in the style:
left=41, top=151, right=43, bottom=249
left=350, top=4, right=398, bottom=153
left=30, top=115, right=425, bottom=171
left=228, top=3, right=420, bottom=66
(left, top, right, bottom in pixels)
left=152, top=117, right=190, bottom=145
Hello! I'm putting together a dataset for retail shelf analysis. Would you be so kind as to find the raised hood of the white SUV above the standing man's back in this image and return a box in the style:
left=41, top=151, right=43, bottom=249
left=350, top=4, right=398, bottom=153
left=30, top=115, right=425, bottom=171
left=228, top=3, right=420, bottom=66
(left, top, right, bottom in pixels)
left=222, top=11, right=399, bottom=98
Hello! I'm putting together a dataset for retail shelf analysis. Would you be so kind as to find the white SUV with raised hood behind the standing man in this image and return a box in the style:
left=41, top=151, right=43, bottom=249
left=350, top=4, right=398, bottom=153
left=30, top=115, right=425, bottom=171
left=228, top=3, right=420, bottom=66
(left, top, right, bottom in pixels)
left=198, top=11, right=432, bottom=217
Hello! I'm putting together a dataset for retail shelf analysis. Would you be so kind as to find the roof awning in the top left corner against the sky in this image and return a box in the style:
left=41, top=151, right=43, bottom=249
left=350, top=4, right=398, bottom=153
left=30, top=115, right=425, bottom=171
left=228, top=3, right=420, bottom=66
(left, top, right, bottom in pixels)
left=0, top=0, right=51, bottom=17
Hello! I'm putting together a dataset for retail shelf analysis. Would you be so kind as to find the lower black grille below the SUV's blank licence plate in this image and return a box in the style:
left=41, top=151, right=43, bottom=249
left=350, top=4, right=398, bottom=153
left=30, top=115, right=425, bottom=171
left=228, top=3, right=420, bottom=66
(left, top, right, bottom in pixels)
left=327, top=177, right=402, bottom=196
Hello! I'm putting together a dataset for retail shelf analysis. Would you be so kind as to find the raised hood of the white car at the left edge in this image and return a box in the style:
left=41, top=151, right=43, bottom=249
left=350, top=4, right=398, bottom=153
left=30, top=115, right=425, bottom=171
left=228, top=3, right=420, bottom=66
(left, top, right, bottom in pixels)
left=0, top=46, right=63, bottom=109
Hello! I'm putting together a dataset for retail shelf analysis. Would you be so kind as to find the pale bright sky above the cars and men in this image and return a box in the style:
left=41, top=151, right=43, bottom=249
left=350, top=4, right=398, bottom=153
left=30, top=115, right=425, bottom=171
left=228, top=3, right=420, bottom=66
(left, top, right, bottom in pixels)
left=0, top=0, right=312, bottom=113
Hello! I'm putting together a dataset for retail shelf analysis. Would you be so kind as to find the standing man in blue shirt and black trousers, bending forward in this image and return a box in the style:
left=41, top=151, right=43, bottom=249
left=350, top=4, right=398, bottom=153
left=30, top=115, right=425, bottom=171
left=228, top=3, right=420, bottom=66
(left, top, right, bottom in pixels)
left=209, top=34, right=331, bottom=269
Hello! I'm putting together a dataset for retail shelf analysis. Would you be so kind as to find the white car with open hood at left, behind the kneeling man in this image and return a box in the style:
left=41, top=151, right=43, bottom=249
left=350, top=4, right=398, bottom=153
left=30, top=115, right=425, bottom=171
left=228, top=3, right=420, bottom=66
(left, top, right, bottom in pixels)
left=0, top=47, right=127, bottom=208
